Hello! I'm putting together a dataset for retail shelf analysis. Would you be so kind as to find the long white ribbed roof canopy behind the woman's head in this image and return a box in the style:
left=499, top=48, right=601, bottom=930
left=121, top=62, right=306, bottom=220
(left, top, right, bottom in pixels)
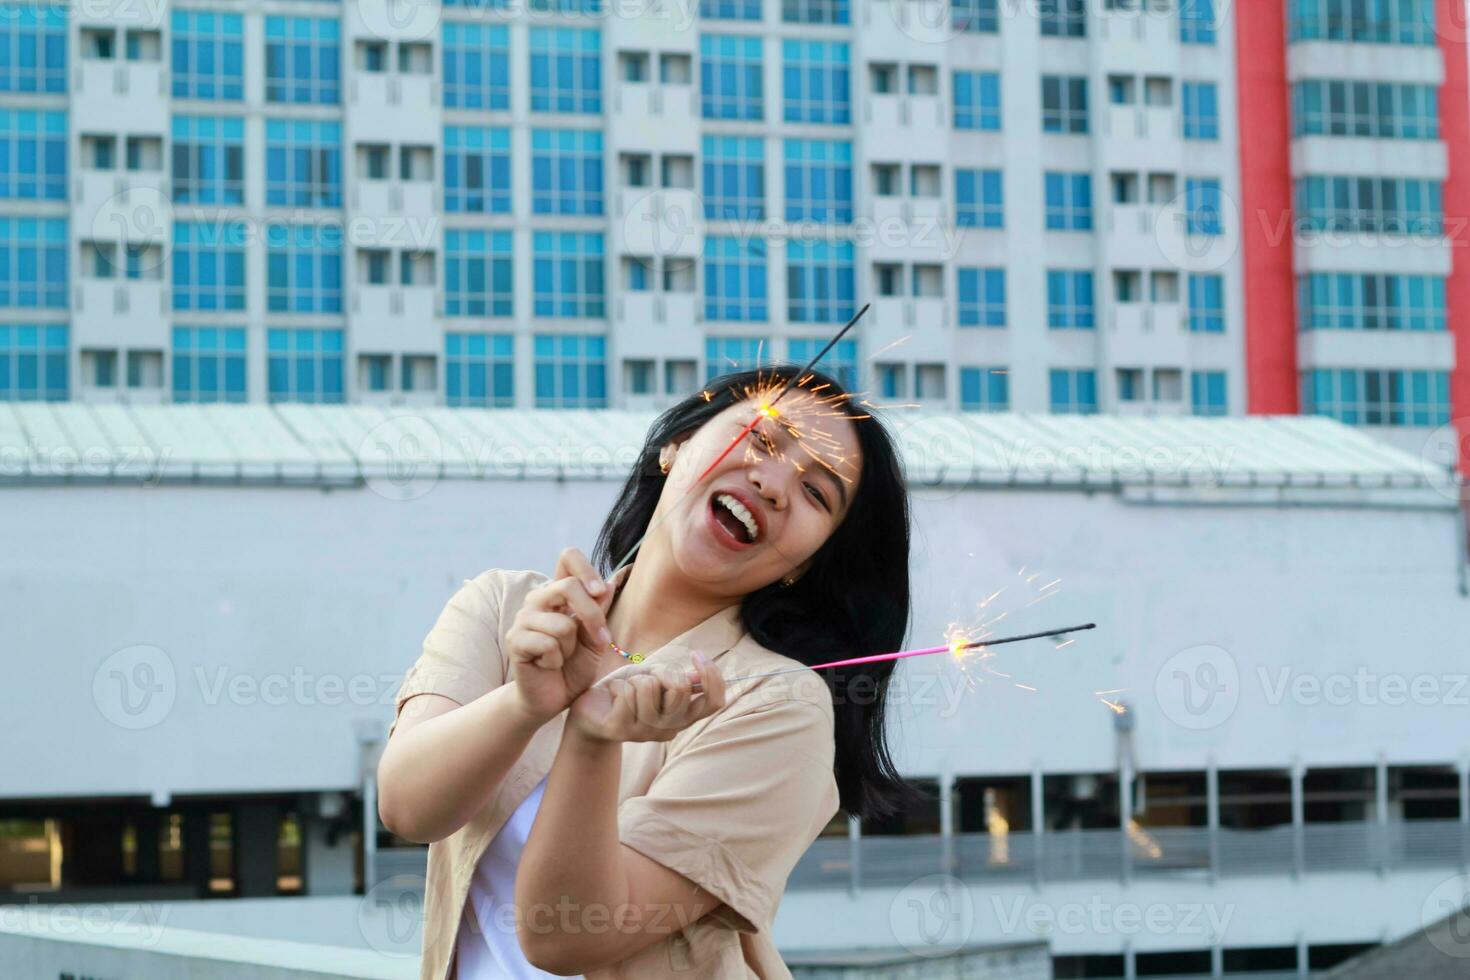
left=0, top=403, right=1454, bottom=504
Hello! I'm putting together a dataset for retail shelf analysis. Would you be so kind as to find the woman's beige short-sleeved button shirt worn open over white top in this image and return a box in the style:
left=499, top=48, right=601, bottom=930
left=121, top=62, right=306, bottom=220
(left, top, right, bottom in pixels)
left=390, top=569, right=838, bottom=980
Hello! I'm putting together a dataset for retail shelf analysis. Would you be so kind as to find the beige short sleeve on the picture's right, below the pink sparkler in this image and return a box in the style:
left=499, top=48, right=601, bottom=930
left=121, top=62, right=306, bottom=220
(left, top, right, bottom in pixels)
left=617, top=699, right=838, bottom=933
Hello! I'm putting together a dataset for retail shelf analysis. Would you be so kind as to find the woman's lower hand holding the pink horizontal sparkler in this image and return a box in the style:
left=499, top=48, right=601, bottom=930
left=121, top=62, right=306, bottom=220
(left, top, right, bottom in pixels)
left=567, top=654, right=725, bottom=742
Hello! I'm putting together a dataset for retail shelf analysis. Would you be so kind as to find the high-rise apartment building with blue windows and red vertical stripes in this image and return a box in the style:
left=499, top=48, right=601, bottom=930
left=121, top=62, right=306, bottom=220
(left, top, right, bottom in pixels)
left=0, top=0, right=1470, bottom=464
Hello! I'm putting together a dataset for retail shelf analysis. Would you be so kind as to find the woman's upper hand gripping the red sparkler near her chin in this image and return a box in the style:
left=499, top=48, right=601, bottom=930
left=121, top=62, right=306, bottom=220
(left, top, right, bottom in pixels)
left=506, top=548, right=613, bottom=723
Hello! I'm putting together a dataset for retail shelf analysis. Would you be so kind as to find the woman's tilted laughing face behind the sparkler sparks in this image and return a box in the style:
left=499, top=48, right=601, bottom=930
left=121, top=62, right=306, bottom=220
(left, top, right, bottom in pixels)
left=654, top=388, right=863, bottom=595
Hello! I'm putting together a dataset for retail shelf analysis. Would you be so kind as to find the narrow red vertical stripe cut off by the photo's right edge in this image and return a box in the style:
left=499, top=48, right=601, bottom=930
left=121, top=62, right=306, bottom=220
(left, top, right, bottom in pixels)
left=1435, top=0, right=1470, bottom=476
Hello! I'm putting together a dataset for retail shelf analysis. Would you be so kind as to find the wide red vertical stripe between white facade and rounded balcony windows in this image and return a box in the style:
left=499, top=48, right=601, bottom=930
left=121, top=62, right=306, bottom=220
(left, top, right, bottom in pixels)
left=1233, top=0, right=1298, bottom=414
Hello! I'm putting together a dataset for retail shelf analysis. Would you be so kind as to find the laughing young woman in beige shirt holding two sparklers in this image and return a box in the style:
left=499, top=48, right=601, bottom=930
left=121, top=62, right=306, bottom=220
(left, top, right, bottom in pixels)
left=378, top=369, right=910, bottom=980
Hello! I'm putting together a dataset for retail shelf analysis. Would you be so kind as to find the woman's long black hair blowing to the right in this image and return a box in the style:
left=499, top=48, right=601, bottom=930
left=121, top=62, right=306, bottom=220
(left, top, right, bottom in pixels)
left=592, top=364, right=919, bottom=818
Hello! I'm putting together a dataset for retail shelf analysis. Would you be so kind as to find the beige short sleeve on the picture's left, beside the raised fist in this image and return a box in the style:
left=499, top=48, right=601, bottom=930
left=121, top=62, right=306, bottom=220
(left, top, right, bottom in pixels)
left=388, top=572, right=506, bottom=738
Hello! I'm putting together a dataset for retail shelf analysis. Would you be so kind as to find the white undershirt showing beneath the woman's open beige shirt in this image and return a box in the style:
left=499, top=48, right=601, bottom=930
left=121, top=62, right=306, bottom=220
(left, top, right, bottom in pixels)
left=456, top=779, right=582, bottom=980
